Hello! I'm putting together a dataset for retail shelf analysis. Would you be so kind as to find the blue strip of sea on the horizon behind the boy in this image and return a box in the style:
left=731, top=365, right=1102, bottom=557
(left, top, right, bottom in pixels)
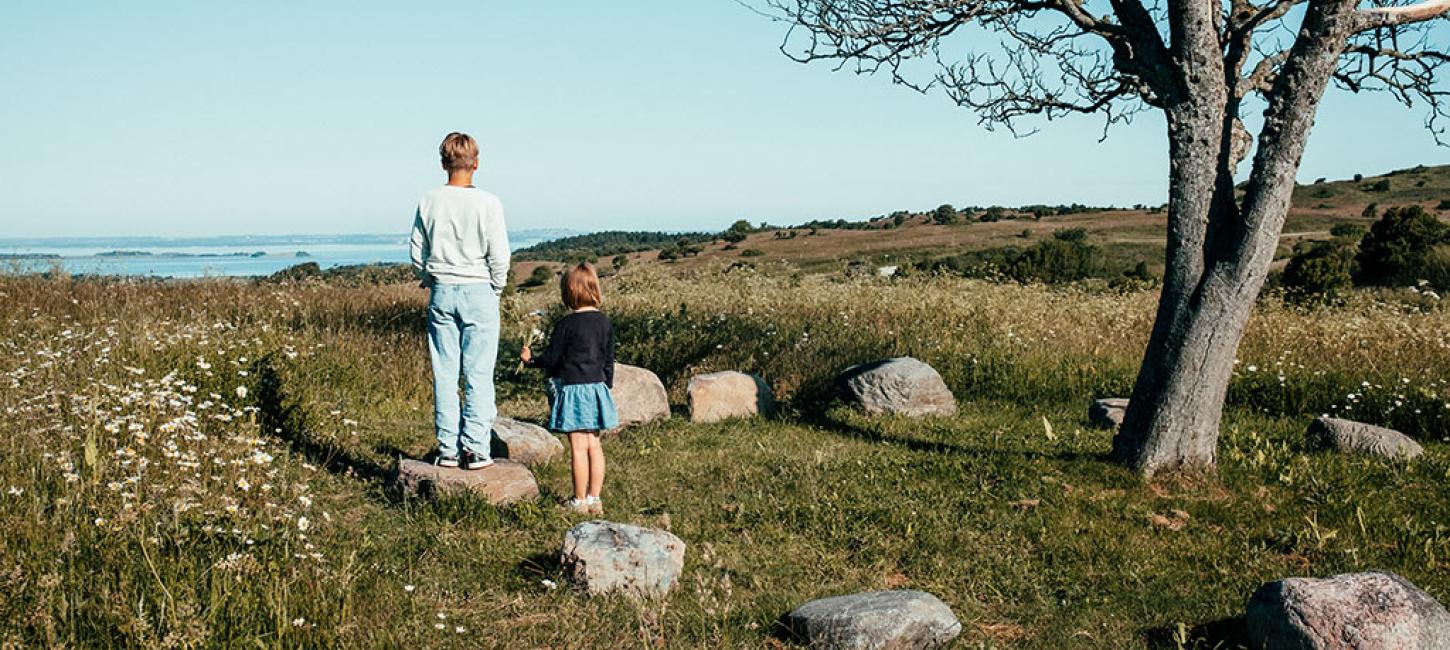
left=0, top=229, right=577, bottom=277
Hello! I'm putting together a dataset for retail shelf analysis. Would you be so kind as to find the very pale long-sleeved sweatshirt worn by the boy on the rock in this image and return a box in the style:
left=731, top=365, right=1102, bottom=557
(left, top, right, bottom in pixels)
left=409, top=186, right=509, bottom=292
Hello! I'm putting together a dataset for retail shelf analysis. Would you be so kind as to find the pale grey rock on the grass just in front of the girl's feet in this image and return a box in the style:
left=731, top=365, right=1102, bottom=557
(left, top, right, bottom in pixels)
left=560, top=521, right=684, bottom=596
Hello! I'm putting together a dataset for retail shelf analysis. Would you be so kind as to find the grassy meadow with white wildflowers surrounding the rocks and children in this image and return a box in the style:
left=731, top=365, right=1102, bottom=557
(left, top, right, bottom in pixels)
left=0, top=265, right=1450, bottom=647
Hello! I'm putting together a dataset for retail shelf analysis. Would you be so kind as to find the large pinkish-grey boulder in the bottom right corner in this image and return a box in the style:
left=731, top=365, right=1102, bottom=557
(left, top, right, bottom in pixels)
left=1244, top=572, right=1450, bottom=650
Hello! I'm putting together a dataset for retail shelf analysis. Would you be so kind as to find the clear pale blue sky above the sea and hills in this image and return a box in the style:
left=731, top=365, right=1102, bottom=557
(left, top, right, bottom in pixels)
left=0, top=0, right=1450, bottom=238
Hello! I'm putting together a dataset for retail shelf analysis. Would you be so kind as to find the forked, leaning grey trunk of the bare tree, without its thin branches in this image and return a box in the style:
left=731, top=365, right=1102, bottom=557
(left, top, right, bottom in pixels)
left=1114, top=0, right=1354, bottom=476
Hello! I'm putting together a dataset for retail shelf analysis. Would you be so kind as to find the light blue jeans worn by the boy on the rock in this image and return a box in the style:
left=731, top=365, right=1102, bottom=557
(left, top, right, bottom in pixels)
left=428, top=281, right=499, bottom=458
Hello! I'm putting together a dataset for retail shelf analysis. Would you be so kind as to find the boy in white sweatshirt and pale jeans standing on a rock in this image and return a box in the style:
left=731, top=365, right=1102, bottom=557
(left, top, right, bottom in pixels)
left=410, top=132, right=509, bottom=470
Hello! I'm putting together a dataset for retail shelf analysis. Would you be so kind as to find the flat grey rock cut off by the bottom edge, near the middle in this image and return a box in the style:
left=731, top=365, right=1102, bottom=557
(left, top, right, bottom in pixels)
left=784, top=589, right=961, bottom=650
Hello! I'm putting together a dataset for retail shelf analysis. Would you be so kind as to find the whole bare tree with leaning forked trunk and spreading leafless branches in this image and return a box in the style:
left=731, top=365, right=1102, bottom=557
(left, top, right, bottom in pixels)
left=763, top=0, right=1450, bottom=474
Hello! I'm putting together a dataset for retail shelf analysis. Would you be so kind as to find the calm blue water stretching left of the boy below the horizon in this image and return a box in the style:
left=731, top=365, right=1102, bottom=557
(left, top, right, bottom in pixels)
left=0, top=238, right=556, bottom=277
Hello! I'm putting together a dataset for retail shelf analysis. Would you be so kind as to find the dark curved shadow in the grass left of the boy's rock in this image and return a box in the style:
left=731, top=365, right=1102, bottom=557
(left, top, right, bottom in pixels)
left=252, top=357, right=403, bottom=482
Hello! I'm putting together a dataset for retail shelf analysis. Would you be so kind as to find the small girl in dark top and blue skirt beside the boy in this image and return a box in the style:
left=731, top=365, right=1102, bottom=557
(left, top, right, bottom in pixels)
left=519, top=263, right=619, bottom=515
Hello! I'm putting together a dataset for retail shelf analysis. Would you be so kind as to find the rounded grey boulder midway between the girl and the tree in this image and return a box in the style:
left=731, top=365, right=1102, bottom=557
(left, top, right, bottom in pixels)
left=837, top=357, right=957, bottom=418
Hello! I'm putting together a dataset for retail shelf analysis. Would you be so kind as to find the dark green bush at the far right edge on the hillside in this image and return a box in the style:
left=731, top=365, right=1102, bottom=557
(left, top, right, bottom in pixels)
left=1356, top=206, right=1450, bottom=286
